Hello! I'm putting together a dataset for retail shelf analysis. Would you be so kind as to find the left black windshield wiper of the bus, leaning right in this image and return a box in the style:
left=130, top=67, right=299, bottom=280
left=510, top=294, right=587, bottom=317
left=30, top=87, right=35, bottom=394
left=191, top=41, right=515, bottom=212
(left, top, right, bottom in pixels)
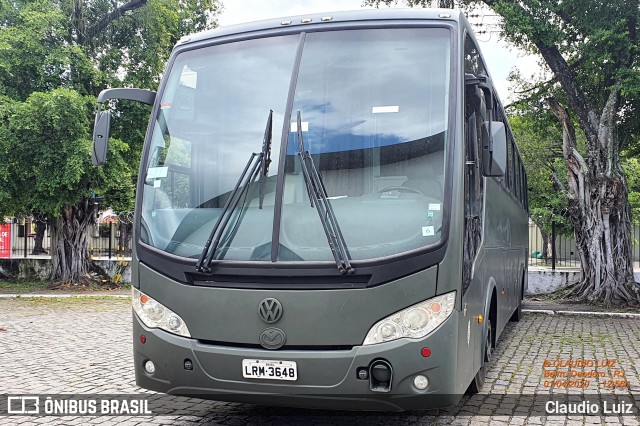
left=196, top=110, right=273, bottom=272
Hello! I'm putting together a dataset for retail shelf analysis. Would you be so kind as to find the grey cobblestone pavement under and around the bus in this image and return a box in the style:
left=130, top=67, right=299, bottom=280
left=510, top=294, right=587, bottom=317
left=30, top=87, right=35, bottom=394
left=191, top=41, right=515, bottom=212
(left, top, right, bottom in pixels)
left=0, top=299, right=640, bottom=426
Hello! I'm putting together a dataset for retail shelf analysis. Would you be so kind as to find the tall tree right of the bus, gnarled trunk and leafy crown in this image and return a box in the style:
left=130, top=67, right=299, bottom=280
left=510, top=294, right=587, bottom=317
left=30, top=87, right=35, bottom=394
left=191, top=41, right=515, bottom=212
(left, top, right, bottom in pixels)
left=365, top=0, right=640, bottom=306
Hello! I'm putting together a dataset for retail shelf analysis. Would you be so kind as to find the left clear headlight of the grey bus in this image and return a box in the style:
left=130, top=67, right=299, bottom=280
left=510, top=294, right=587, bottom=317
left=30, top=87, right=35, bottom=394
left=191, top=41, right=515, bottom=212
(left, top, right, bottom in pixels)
left=131, top=287, right=191, bottom=337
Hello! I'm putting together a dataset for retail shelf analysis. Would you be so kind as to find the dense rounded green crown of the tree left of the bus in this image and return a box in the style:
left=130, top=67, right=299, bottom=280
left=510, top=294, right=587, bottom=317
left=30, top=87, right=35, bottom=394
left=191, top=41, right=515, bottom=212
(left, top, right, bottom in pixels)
left=5, top=89, right=133, bottom=217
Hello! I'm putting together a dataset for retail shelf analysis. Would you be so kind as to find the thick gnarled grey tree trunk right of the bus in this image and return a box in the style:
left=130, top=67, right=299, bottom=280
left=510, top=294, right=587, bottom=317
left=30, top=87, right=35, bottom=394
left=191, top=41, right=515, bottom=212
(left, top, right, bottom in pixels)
left=547, top=96, right=640, bottom=307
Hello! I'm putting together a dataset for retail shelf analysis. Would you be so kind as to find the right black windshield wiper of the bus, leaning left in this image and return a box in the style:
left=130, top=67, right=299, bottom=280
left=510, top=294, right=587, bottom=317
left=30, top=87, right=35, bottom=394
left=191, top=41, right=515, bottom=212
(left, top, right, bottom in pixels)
left=297, top=111, right=355, bottom=274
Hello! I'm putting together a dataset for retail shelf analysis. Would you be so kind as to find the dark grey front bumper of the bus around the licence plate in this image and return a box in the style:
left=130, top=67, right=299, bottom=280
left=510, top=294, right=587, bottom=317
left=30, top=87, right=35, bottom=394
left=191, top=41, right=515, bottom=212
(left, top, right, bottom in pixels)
left=133, top=313, right=466, bottom=411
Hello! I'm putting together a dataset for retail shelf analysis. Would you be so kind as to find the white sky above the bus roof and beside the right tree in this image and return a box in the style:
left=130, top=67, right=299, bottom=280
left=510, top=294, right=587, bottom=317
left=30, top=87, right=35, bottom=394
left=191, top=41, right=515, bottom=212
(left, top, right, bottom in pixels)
left=218, top=0, right=539, bottom=105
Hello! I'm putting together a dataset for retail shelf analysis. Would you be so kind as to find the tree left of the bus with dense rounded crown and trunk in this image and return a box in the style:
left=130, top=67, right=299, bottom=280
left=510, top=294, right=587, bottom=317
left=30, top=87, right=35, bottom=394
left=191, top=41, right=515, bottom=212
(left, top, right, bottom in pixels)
left=3, top=89, right=133, bottom=282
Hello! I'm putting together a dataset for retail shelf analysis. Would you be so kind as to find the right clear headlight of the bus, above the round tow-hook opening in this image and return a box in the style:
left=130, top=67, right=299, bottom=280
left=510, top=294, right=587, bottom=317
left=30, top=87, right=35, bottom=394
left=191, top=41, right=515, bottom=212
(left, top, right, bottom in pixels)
left=363, top=291, right=456, bottom=345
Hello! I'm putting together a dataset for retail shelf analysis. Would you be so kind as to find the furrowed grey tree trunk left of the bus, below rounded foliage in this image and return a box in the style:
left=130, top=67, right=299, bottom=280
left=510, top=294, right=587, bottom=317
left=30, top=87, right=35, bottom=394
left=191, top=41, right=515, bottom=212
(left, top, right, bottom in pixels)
left=51, top=200, right=97, bottom=283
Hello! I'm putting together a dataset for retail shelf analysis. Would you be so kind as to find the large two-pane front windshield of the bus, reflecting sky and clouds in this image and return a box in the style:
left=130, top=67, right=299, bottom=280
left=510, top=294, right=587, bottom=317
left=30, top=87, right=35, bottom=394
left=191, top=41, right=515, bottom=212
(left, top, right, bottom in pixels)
left=140, top=28, right=451, bottom=262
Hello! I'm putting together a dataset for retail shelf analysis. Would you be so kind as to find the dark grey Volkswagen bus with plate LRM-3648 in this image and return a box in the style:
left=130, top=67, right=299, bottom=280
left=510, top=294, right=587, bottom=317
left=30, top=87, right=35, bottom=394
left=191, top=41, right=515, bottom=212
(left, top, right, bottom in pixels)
left=93, top=9, right=528, bottom=410
